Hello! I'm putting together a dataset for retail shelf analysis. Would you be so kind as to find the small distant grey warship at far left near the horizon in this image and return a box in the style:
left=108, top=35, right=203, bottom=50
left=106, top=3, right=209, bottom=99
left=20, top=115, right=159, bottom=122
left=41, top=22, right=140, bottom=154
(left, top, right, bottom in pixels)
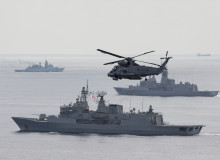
left=15, top=60, right=64, bottom=72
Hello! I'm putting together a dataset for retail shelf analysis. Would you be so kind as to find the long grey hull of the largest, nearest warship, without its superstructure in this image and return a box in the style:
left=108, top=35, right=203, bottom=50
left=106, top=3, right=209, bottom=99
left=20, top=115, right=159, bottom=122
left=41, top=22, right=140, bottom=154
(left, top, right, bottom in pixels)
left=12, top=117, right=203, bottom=136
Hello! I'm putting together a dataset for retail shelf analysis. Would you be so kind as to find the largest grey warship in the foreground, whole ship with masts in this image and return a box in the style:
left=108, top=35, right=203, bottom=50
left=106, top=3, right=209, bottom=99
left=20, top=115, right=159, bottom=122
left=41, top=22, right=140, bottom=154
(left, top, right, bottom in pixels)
left=12, top=83, right=203, bottom=136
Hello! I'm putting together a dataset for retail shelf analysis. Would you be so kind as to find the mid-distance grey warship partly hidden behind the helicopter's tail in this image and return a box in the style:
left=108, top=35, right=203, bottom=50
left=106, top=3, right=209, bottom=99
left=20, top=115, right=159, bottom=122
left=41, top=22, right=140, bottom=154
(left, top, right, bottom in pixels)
left=114, top=70, right=218, bottom=97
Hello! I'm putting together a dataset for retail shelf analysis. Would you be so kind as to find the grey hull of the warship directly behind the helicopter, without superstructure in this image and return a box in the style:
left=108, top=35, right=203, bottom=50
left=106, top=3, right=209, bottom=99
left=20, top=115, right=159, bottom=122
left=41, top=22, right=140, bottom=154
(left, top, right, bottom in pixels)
left=114, top=87, right=218, bottom=97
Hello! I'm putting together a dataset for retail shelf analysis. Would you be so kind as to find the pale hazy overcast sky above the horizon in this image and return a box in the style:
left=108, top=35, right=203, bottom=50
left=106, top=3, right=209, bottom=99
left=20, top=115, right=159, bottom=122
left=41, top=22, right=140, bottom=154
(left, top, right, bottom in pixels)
left=0, top=0, right=220, bottom=55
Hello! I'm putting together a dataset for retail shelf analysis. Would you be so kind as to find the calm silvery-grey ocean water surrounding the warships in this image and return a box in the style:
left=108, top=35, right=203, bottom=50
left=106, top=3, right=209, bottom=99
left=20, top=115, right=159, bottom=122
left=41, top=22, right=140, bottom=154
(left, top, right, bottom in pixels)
left=0, top=54, right=220, bottom=160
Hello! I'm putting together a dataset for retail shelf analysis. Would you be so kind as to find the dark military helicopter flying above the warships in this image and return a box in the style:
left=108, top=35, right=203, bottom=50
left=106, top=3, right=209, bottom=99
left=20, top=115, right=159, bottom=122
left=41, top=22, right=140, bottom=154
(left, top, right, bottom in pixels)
left=97, top=49, right=172, bottom=80
